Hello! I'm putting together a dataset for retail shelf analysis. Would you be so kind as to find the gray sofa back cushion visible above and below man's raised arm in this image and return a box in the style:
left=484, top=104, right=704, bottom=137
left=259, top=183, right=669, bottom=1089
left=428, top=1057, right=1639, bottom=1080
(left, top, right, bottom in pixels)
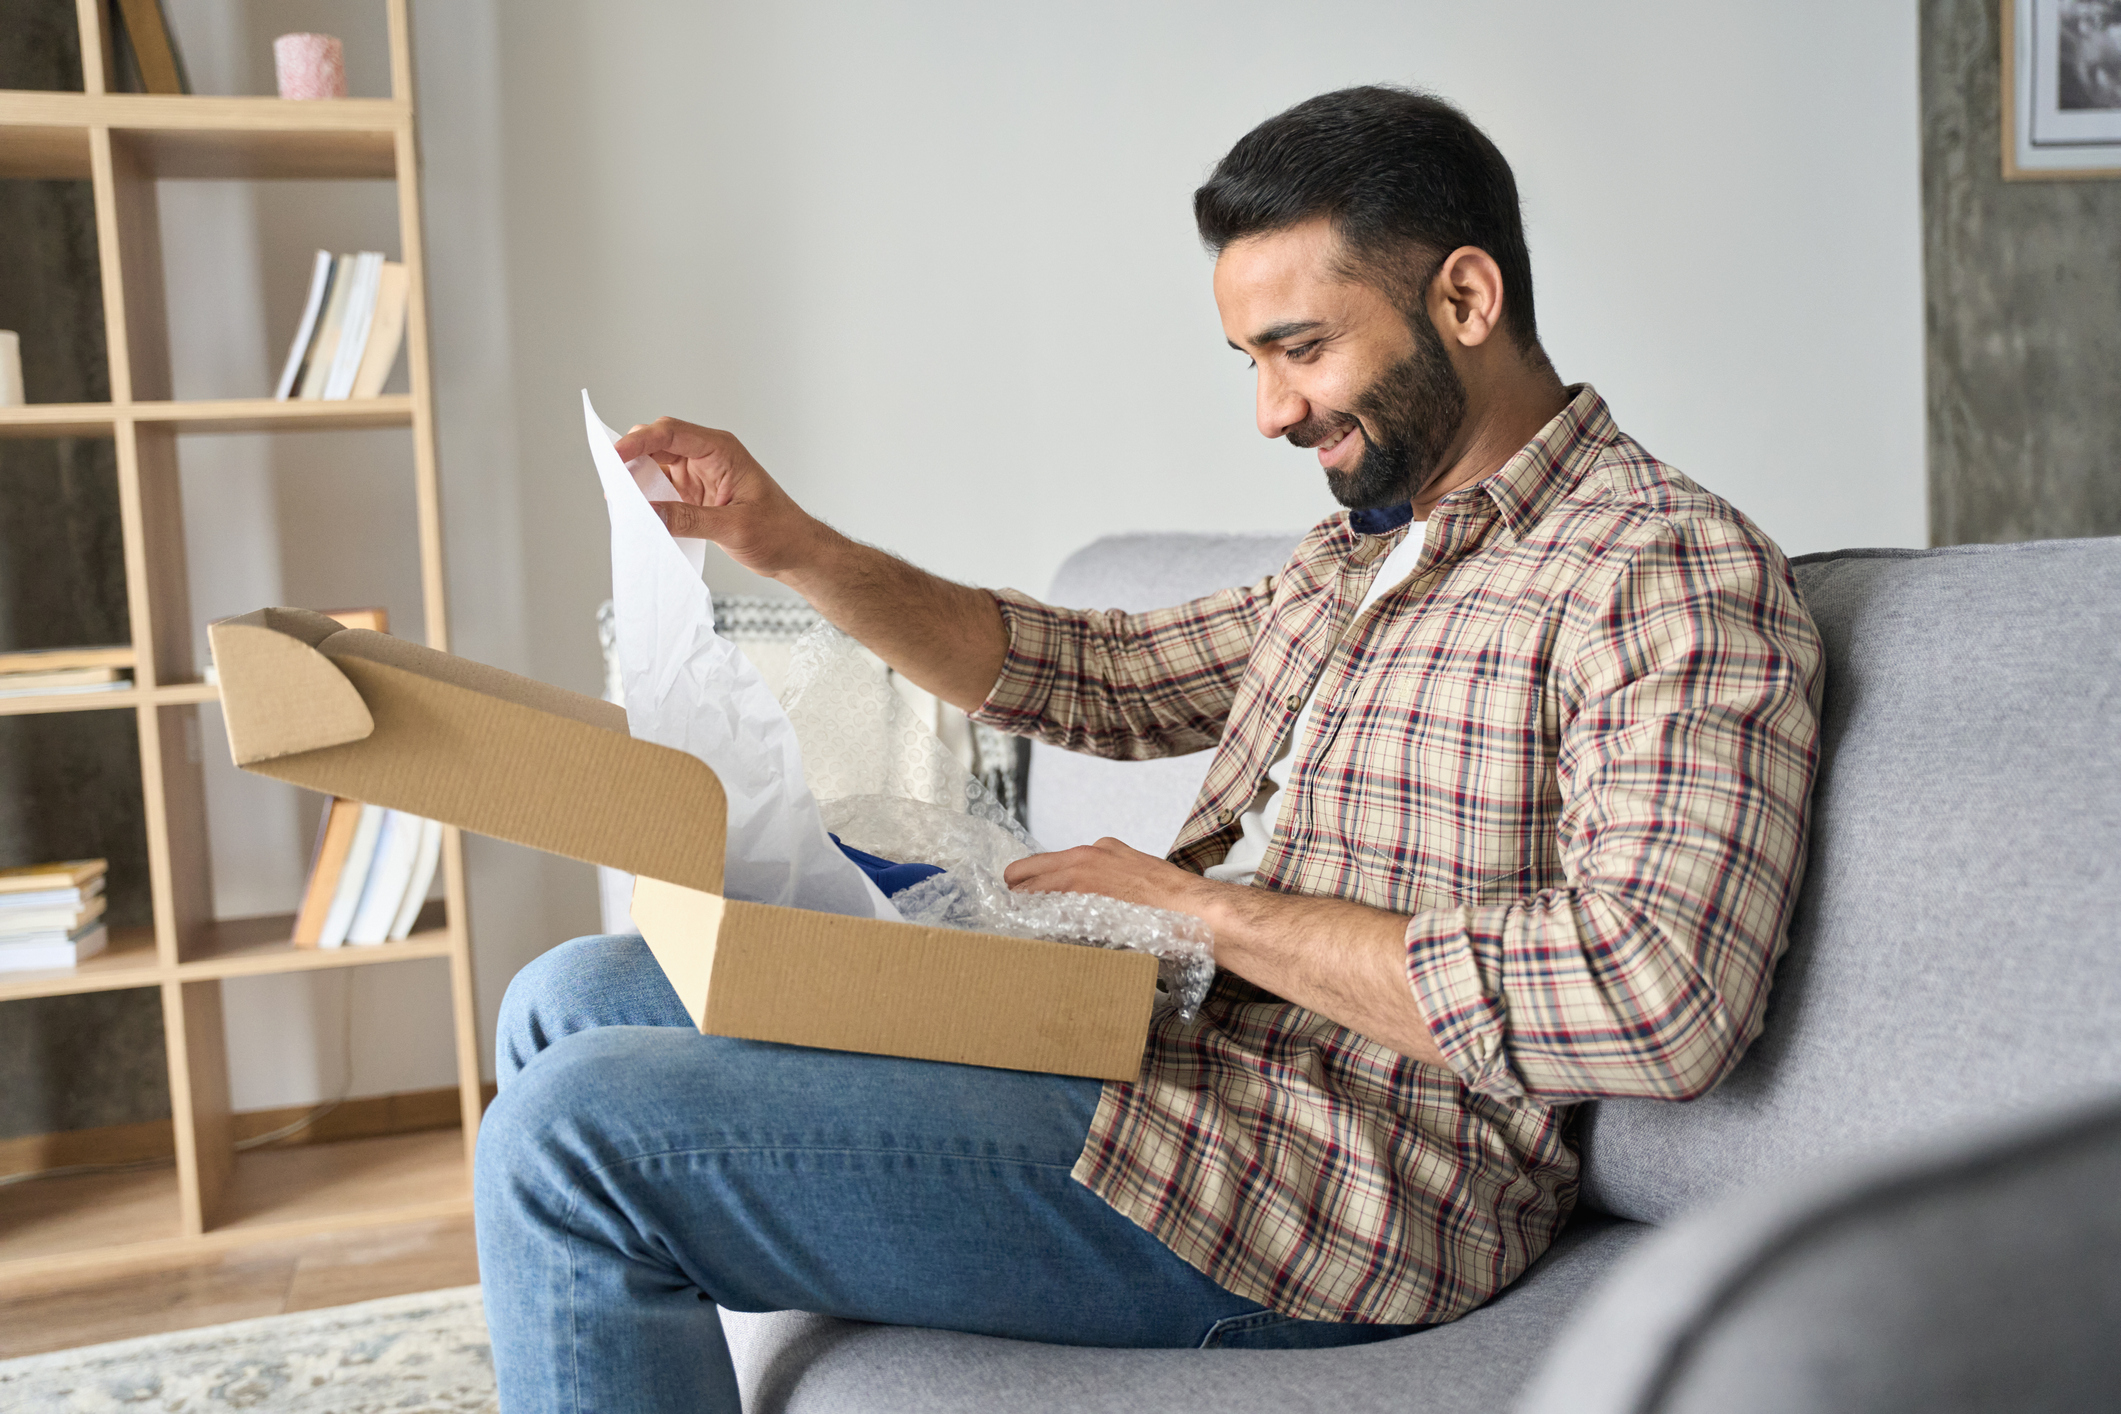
left=1027, top=532, right=1302, bottom=854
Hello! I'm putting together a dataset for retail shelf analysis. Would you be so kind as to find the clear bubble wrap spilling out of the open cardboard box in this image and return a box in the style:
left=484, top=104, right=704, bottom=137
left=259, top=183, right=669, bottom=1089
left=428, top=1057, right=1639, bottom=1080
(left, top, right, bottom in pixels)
left=823, top=795, right=1215, bottom=1020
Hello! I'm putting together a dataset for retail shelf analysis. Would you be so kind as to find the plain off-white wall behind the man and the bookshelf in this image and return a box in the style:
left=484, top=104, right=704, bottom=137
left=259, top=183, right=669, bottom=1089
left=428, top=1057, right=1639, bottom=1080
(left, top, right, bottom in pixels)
left=156, top=0, right=1926, bottom=1102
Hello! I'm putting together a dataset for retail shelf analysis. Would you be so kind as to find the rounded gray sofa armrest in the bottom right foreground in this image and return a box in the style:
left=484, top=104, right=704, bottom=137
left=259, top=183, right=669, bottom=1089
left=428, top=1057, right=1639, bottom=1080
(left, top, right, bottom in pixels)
left=1521, top=1102, right=2121, bottom=1414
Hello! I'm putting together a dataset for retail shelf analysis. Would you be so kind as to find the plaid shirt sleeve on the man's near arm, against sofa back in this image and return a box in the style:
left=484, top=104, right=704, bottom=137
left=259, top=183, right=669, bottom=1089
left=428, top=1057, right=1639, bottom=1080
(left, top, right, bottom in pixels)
left=1406, top=519, right=1822, bottom=1102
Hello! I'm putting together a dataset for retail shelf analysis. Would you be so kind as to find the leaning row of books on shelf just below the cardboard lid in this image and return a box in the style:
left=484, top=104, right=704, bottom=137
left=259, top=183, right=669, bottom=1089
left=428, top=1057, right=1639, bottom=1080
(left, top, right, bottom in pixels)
left=295, top=799, right=441, bottom=948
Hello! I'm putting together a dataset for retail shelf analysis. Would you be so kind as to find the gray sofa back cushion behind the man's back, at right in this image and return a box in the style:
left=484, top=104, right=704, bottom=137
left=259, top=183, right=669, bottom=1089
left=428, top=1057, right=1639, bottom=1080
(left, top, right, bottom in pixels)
left=1580, top=538, right=2121, bottom=1221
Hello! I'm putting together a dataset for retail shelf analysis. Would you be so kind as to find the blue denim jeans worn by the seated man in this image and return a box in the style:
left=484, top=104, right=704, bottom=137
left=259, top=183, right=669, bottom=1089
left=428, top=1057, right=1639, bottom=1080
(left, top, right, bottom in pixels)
left=475, top=937, right=1419, bottom=1414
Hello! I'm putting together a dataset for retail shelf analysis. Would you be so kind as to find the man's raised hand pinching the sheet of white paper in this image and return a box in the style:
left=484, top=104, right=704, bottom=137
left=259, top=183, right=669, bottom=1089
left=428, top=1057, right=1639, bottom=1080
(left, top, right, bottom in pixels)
left=617, top=418, right=831, bottom=579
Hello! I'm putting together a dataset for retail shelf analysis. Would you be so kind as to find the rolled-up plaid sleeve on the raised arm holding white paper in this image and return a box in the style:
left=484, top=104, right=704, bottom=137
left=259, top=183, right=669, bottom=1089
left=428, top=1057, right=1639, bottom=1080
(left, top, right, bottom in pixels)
left=971, top=579, right=1275, bottom=761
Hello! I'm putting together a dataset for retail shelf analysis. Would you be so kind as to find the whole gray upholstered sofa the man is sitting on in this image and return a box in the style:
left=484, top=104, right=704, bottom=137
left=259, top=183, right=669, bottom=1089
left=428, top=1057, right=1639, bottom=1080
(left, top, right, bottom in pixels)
left=723, top=536, right=2121, bottom=1414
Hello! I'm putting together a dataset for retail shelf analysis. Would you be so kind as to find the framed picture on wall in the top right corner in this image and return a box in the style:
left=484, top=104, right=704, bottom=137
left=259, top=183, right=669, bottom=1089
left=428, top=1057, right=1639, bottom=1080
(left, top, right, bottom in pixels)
left=2002, top=0, right=2121, bottom=182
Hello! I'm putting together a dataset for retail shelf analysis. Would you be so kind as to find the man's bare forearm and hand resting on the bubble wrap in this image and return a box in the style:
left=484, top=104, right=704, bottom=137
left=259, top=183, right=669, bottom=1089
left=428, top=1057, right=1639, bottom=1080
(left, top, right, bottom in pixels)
left=1001, top=839, right=1449, bottom=1068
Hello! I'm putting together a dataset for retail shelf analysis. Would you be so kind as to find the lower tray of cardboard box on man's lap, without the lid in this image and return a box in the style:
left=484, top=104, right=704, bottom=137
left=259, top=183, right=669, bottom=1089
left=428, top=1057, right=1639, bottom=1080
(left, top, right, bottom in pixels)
left=634, top=878, right=1156, bottom=1081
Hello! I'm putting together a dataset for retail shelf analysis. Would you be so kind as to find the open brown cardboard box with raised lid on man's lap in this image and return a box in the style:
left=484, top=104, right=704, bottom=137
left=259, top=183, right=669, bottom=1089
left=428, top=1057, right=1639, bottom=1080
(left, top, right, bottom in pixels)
left=208, top=608, right=1156, bottom=1079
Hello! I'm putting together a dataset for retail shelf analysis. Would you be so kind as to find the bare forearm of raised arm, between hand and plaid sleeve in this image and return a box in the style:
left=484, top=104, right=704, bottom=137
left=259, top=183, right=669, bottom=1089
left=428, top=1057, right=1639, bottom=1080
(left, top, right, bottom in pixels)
left=774, top=524, right=1010, bottom=712
